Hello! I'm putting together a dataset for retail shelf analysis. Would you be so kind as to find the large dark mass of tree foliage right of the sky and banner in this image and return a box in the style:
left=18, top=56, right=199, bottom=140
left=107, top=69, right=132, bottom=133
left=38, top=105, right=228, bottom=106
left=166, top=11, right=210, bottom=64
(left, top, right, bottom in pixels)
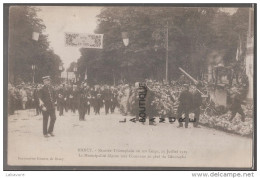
left=71, top=6, right=250, bottom=84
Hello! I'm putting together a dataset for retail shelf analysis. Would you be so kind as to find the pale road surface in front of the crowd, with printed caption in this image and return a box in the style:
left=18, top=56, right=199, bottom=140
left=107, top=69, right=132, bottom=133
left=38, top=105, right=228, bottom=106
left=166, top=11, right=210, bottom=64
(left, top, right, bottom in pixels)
left=8, top=110, right=252, bottom=167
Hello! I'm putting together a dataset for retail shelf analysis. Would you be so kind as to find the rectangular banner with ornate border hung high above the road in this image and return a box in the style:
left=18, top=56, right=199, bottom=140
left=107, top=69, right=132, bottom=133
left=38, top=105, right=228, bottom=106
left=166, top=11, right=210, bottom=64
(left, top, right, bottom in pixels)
left=65, top=33, right=103, bottom=49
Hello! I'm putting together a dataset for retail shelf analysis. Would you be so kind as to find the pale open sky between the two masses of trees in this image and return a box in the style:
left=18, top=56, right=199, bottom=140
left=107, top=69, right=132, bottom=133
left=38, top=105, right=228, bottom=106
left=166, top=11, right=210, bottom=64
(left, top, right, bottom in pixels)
left=38, top=6, right=102, bottom=68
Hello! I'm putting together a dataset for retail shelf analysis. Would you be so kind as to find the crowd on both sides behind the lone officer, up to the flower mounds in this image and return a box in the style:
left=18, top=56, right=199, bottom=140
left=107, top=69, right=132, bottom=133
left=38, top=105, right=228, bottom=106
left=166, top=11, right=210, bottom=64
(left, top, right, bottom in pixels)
left=8, top=83, right=118, bottom=120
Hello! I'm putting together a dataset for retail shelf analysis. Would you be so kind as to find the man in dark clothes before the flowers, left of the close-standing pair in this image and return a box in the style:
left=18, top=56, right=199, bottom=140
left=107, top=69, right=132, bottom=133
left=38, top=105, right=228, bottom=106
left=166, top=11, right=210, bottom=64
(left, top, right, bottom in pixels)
left=177, top=84, right=192, bottom=128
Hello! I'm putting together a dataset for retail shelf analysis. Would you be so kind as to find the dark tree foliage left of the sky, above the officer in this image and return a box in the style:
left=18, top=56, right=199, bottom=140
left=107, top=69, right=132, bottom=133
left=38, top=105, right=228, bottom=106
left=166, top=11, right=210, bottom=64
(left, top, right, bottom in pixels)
left=8, top=6, right=61, bottom=83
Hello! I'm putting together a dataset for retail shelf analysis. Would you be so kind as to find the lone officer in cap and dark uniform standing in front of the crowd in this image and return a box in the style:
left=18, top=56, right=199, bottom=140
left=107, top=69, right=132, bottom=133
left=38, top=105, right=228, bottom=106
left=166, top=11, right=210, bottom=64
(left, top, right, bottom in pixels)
left=39, top=76, right=56, bottom=137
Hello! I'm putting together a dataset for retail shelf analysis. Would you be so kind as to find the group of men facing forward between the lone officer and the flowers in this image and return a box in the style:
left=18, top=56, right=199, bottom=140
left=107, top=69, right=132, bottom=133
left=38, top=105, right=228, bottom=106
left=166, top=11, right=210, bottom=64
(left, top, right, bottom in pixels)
left=56, top=83, right=118, bottom=120
